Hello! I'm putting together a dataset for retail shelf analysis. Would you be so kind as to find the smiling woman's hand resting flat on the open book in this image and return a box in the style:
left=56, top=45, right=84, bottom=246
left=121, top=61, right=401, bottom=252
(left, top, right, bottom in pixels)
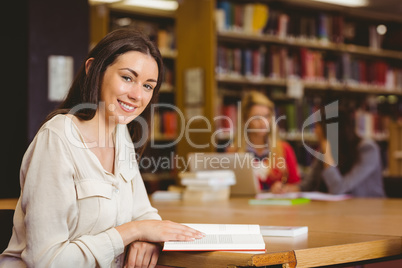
left=116, top=220, right=204, bottom=246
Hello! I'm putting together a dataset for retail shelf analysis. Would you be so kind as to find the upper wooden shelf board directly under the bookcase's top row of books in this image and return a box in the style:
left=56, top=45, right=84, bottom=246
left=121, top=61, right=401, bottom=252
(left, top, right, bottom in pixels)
left=218, top=31, right=402, bottom=60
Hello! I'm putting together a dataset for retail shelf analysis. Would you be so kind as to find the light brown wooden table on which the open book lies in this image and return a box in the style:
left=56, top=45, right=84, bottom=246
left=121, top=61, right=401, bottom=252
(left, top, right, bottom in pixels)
left=152, top=198, right=402, bottom=268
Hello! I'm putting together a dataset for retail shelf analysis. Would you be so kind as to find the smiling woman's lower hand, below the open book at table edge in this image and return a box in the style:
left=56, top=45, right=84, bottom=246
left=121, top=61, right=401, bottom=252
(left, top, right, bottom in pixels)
left=124, top=241, right=160, bottom=268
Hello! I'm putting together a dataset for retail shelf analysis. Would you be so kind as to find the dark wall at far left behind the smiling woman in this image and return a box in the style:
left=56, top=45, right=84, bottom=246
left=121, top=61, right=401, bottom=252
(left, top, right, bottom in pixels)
left=0, top=0, right=89, bottom=198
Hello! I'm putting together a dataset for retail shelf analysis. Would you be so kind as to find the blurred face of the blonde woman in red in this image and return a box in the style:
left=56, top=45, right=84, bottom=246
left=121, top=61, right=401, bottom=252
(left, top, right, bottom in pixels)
left=246, top=104, right=272, bottom=136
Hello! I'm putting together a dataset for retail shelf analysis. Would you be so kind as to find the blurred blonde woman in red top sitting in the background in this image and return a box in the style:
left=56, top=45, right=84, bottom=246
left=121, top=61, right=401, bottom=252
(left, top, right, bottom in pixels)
left=226, top=91, right=300, bottom=193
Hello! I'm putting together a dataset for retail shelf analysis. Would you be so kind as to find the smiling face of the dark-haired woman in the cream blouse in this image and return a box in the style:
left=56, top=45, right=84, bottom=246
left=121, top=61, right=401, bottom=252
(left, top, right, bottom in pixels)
left=101, top=51, right=158, bottom=124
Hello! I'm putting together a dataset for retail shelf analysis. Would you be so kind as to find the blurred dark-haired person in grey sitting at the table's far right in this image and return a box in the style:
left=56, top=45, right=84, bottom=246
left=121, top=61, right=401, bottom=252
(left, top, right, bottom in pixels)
left=283, top=107, right=385, bottom=197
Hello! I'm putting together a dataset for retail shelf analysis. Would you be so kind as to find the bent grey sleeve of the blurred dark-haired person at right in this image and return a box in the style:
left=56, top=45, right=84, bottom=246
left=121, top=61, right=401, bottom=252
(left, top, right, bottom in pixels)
left=322, top=140, right=381, bottom=194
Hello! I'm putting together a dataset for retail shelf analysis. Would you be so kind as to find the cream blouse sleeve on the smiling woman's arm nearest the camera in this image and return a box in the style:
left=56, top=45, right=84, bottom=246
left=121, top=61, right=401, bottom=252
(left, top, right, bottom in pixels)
left=17, top=129, right=124, bottom=268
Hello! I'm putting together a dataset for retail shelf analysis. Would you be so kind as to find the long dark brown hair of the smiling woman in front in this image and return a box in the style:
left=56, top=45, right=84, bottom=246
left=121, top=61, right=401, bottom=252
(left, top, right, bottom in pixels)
left=45, top=29, right=163, bottom=155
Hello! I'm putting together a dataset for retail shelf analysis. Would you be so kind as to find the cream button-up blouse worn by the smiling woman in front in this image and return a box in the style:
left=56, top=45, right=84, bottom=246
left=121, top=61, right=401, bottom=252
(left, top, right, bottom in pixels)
left=0, top=115, right=161, bottom=268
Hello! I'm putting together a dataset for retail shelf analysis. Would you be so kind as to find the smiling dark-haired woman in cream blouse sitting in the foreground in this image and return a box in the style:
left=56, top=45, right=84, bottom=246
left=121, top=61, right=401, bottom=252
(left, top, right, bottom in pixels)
left=0, top=29, right=203, bottom=267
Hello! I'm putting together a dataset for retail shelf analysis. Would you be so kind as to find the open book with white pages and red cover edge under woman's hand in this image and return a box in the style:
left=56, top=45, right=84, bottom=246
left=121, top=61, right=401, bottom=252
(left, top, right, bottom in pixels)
left=163, top=224, right=265, bottom=251
